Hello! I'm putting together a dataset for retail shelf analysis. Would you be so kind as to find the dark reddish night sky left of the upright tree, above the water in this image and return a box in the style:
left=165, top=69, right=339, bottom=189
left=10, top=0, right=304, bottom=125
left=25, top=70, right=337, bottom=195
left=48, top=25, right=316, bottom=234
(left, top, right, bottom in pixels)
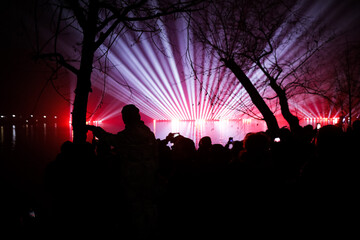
left=0, top=0, right=69, bottom=115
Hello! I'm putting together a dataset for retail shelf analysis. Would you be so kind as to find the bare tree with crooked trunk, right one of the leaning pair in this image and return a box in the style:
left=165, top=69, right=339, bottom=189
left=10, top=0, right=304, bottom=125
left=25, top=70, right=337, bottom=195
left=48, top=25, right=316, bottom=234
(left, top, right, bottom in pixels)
left=247, top=5, right=334, bottom=131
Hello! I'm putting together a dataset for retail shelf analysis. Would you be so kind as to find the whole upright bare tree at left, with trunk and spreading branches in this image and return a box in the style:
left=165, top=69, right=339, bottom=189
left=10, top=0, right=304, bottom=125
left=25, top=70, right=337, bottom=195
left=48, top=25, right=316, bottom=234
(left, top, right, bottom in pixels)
left=36, top=0, right=201, bottom=143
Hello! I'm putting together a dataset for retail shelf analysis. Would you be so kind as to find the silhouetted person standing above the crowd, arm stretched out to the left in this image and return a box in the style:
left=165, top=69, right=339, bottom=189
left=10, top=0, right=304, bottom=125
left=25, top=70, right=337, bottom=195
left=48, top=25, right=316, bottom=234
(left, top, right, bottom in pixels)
left=88, top=104, right=158, bottom=239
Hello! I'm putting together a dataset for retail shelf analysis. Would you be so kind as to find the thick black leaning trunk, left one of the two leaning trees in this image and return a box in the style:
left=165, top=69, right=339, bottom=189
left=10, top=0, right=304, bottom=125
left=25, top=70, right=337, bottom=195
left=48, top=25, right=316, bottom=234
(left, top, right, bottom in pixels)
left=222, top=59, right=279, bottom=137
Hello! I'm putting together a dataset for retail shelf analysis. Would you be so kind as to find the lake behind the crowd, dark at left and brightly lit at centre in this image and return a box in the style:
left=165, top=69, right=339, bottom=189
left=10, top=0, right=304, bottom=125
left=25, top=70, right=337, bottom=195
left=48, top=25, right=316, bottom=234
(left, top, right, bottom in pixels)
left=0, top=119, right=332, bottom=220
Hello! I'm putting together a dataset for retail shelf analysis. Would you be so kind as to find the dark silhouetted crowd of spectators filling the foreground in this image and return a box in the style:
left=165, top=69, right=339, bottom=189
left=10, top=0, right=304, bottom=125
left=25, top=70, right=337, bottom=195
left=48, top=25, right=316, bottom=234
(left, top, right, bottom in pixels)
left=30, top=105, right=360, bottom=239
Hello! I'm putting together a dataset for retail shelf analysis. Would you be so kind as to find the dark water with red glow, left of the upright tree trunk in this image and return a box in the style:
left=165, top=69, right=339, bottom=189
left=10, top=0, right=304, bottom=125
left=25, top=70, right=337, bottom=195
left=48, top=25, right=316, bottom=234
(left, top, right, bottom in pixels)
left=0, top=123, right=70, bottom=212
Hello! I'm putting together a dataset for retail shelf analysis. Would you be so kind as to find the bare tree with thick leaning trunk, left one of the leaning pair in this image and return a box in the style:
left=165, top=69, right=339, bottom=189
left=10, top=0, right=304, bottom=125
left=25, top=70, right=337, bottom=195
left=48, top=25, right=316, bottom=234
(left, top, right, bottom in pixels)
left=189, top=0, right=279, bottom=134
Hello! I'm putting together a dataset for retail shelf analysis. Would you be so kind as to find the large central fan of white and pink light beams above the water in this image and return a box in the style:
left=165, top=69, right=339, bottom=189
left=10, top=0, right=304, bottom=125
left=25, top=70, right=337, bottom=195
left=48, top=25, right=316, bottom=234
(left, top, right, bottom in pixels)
left=89, top=15, right=253, bottom=120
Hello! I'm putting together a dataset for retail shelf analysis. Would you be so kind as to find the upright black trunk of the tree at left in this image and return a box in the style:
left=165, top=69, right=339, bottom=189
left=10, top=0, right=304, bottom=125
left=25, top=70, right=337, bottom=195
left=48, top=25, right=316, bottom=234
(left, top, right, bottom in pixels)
left=72, top=1, right=98, bottom=143
